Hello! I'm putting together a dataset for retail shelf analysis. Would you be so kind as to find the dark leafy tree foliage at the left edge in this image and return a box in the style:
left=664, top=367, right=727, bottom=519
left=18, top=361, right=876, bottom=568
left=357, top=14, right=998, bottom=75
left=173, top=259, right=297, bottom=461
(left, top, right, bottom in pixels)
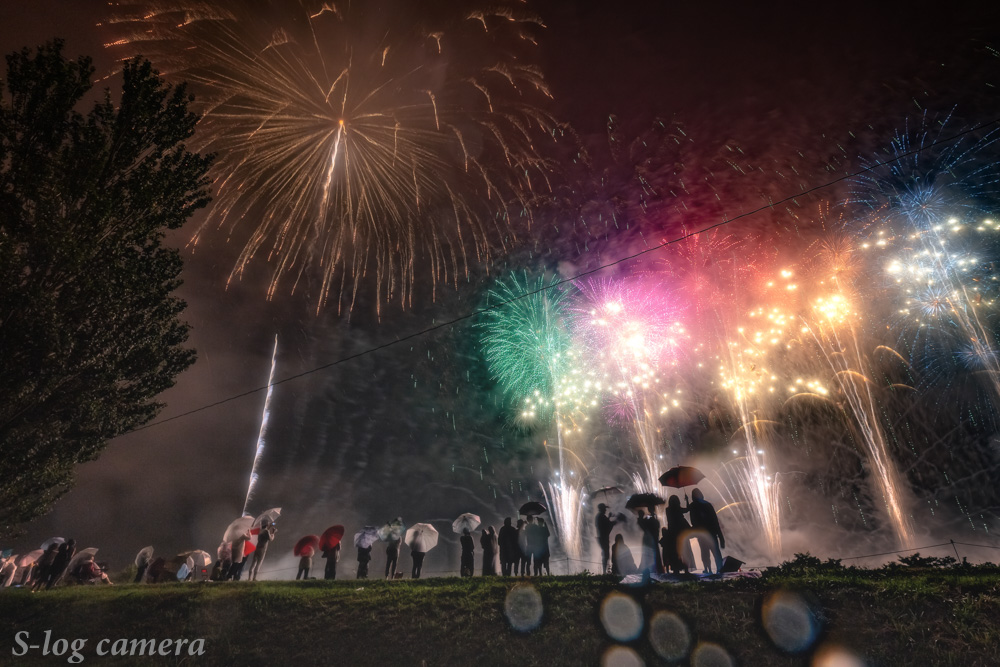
left=0, top=41, right=211, bottom=534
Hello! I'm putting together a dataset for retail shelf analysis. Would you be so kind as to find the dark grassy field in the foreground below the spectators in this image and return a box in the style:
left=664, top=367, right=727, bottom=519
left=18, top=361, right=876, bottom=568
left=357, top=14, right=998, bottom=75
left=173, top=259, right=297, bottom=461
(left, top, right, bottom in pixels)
left=0, top=567, right=1000, bottom=667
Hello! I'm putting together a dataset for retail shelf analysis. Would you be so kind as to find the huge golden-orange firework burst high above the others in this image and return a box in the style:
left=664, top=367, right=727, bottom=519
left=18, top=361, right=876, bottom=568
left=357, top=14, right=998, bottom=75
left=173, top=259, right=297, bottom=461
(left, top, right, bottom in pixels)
left=108, top=0, right=554, bottom=314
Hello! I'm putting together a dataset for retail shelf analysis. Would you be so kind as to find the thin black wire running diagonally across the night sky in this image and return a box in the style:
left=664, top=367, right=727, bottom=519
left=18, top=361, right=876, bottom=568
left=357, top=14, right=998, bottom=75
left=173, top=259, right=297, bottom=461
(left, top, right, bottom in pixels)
left=125, top=118, right=1000, bottom=437
